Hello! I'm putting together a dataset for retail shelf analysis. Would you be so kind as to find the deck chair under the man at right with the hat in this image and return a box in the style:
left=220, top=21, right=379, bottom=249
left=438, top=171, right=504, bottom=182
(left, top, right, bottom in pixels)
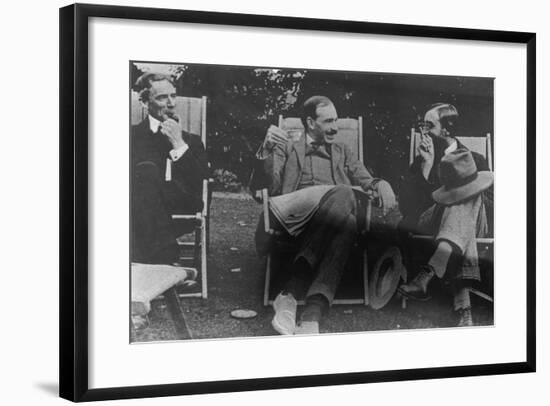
left=408, top=128, right=494, bottom=307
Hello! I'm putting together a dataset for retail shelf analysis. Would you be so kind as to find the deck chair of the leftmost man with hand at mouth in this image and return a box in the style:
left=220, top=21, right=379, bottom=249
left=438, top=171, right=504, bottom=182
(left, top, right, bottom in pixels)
left=131, top=91, right=211, bottom=299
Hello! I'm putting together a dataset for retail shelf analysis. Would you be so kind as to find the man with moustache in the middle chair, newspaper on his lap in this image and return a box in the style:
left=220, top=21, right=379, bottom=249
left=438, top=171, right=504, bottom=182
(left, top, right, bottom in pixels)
left=256, top=96, right=396, bottom=334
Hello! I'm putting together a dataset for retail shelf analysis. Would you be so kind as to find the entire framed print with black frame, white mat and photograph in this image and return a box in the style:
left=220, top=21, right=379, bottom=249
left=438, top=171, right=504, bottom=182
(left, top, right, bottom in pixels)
left=60, top=4, right=536, bottom=401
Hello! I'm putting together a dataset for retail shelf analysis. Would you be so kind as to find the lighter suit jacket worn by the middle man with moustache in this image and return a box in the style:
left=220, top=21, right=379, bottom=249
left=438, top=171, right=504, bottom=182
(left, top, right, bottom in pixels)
left=263, top=135, right=375, bottom=196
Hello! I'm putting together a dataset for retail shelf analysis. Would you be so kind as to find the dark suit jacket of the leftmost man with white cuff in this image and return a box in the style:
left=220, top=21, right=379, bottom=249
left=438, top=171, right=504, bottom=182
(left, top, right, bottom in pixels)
left=131, top=118, right=209, bottom=197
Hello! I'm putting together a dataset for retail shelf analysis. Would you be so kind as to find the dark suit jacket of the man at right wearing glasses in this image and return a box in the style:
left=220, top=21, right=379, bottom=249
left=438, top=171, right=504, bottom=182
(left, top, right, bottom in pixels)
left=399, top=140, right=493, bottom=229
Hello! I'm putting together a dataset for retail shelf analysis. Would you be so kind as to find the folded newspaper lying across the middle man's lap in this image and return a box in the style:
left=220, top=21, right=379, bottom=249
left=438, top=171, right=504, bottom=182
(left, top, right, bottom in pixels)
left=269, top=185, right=369, bottom=236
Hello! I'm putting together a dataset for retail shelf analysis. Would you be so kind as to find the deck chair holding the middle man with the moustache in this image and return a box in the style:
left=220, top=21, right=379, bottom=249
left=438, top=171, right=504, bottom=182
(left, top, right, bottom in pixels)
left=261, top=116, right=401, bottom=308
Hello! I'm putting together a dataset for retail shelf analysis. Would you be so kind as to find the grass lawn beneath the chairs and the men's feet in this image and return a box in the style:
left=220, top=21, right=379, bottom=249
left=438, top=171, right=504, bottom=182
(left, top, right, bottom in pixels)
left=135, top=194, right=493, bottom=341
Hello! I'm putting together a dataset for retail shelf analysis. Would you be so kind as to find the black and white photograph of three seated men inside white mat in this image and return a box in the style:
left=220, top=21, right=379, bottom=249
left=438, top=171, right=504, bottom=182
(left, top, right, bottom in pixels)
left=128, top=61, right=499, bottom=343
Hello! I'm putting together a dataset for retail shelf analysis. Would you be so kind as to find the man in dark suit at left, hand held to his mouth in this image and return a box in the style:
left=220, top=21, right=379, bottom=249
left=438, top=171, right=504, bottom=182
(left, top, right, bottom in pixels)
left=131, top=73, right=208, bottom=264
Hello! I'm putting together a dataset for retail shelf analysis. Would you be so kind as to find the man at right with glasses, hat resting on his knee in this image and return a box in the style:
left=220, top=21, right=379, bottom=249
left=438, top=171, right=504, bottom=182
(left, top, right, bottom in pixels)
left=399, top=103, right=493, bottom=326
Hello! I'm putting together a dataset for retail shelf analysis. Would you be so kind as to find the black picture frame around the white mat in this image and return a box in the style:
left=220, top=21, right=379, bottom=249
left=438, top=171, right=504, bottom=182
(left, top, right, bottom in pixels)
left=59, top=4, right=536, bottom=402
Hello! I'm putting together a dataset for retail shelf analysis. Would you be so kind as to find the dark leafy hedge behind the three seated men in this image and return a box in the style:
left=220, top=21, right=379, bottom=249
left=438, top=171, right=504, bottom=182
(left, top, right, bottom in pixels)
left=131, top=63, right=493, bottom=195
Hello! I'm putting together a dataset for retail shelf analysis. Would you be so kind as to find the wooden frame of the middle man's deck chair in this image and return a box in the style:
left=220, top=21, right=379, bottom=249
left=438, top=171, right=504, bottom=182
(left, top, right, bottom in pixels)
left=261, top=115, right=372, bottom=306
